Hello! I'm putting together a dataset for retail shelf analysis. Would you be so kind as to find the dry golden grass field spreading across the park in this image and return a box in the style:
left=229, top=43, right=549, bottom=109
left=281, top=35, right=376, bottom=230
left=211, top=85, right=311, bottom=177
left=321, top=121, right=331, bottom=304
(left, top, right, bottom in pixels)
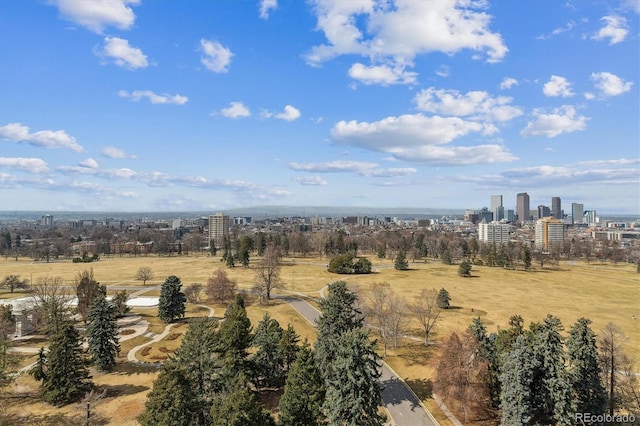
left=0, top=256, right=640, bottom=425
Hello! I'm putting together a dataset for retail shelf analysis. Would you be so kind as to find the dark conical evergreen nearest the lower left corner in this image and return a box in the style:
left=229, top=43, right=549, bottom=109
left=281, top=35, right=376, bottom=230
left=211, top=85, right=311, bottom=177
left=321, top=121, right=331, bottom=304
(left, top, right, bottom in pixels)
left=40, top=324, right=93, bottom=406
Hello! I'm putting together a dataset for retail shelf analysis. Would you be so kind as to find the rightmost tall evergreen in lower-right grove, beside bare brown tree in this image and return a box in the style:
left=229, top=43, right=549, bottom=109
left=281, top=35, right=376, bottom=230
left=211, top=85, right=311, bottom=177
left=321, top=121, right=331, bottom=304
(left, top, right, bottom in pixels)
left=567, top=318, right=607, bottom=415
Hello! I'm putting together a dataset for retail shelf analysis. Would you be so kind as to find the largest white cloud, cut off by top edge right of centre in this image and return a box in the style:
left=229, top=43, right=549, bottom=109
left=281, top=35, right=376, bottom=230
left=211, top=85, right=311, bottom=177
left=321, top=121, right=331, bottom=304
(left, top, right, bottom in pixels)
left=305, top=0, right=508, bottom=85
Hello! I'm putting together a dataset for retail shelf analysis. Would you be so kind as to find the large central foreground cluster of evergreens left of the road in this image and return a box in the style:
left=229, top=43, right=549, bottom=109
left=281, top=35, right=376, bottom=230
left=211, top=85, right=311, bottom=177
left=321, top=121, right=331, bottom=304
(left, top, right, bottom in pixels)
left=138, top=282, right=384, bottom=426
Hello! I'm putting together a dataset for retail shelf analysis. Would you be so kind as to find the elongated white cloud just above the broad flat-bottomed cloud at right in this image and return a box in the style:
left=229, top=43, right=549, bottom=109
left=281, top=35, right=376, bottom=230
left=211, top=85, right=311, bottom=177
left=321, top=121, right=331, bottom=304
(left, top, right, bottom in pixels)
left=414, top=87, right=522, bottom=121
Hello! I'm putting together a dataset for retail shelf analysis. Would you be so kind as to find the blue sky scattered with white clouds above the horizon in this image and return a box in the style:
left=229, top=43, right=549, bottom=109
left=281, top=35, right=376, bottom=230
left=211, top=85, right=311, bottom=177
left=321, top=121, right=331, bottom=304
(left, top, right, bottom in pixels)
left=0, top=0, right=640, bottom=214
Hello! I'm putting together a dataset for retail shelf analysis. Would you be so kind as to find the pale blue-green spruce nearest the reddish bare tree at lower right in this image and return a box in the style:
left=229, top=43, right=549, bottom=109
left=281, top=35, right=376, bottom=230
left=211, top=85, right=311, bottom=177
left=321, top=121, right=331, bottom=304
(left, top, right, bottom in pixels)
left=500, top=335, right=537, bottom=426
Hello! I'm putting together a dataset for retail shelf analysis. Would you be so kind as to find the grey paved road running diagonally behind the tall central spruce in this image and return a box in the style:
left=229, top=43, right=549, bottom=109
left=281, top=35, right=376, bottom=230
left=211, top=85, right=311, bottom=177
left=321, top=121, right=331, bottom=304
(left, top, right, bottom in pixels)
left=281, top=296, right=438, bottom=426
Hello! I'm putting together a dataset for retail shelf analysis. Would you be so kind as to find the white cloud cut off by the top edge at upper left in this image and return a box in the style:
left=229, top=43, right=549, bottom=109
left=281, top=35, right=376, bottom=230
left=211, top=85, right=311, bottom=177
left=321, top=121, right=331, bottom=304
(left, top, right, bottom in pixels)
left=51, top=0, right=140, bottom=34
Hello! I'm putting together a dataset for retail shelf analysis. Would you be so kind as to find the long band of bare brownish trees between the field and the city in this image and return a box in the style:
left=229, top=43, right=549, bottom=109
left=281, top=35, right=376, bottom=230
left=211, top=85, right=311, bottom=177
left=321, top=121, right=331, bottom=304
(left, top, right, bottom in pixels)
left=0, top=224, right=640, bottom=268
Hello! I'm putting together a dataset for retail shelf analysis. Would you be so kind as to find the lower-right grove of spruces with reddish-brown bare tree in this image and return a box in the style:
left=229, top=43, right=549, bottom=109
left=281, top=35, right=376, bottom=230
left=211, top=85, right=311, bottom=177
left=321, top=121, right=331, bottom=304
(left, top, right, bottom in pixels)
left=434, top=315, right=640, bottom=426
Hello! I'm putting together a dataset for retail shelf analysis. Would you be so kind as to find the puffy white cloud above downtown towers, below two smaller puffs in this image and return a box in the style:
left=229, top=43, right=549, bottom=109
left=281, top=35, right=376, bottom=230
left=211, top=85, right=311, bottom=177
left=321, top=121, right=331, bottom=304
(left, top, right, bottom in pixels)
left=520, top=105, right=589, bottom=138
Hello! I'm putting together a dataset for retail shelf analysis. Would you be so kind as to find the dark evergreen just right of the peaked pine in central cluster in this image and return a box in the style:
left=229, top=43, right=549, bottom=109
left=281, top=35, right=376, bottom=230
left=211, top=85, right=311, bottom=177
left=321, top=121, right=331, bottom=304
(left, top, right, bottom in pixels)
left=252, top=313, right=285, bottom=387
